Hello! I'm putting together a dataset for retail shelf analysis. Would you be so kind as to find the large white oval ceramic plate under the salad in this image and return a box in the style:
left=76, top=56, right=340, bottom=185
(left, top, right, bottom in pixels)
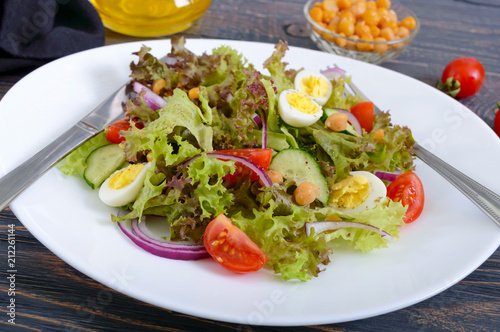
left=0, top=40, right=500, bottom=325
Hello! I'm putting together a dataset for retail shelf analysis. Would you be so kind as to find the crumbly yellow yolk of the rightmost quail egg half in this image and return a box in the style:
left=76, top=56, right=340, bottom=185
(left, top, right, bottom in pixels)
left=330, top=175, right=370, bottom=209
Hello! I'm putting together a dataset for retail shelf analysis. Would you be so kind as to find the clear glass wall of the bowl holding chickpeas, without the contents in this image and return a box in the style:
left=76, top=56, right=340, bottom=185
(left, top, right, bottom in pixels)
left=304, top=0, right=420, bottom=64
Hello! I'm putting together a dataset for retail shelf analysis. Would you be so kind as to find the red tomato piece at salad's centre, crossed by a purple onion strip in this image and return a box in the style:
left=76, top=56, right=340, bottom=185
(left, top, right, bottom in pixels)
left=215, top=149, right=273, bottom=183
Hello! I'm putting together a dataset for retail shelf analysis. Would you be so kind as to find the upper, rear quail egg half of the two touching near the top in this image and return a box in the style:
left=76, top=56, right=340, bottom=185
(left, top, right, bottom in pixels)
left=294, top=70, right=333, bottom=106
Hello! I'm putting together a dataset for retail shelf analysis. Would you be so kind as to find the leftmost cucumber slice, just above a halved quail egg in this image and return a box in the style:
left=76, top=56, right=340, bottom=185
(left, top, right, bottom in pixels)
left=83, top=144, right=125, bottom=189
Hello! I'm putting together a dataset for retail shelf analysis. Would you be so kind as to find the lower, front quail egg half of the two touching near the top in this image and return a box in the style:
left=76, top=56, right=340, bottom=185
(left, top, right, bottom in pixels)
left=278, top=89, right=323, bottom=128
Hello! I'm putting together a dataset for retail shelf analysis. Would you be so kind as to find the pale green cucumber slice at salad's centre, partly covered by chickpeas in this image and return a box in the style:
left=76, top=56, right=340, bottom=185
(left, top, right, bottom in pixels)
left=269, top=149, right=330, bottom=205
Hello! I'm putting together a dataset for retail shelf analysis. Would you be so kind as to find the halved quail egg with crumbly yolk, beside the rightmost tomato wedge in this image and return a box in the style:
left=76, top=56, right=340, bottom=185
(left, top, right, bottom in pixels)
left=329, top=171, right=387, bottom=213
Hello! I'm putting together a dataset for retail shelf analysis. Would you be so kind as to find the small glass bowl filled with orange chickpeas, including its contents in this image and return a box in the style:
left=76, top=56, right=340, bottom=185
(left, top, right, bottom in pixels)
left=304, top=0, right=420, bottom=64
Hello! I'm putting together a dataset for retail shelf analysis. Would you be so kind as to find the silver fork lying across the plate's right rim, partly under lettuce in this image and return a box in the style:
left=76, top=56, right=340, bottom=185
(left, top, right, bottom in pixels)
left=347, top=74, right=500, bottom=226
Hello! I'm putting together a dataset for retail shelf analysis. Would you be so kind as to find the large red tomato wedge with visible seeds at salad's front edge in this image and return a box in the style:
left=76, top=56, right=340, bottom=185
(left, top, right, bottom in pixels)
left=203, top=213, right=268, bottom=273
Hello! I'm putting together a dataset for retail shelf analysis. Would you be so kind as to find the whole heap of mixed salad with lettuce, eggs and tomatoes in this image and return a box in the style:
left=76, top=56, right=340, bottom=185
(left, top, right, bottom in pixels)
left=59, top=37, right=423, bottom=281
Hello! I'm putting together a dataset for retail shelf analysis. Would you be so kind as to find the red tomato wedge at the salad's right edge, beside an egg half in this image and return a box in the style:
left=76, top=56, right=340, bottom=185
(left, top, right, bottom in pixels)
left=387, top=172, right=425, bottom=224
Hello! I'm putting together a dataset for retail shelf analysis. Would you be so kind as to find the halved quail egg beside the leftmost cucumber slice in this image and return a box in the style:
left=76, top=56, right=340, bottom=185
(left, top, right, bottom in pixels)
left=99, top=163, right=150, bottom=207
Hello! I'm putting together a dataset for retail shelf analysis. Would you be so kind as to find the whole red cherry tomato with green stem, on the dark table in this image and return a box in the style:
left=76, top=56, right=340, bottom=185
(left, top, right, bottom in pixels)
left=438, top=57, right=485, bottom=98
